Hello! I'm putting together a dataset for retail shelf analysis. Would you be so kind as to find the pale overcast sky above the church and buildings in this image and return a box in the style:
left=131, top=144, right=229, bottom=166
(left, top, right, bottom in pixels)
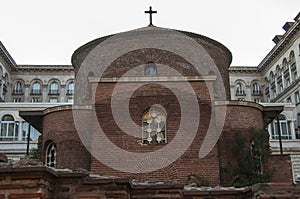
left=0, top=0, right=300, bottom=66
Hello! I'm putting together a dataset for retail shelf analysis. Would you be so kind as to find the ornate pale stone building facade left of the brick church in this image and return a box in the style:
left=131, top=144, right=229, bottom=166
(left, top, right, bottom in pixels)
left=0, top=42, right=74, bottom=159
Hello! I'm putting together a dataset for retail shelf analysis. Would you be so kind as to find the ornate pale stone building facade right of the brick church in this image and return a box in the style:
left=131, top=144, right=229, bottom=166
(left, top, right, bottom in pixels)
left=230, top=13, right=300, bottom=181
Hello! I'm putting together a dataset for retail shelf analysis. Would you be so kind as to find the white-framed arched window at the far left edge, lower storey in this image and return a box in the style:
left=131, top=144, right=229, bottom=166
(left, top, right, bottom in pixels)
left=0, top=115, right=19, bottom=141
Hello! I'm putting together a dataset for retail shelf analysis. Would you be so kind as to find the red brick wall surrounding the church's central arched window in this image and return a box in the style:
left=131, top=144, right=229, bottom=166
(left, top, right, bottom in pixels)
left=91, top=82, right=219, bottom=185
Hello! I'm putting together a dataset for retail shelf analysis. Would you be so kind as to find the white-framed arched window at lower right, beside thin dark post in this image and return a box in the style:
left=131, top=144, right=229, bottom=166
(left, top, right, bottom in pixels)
left=270, top=115, right=292, bottom=140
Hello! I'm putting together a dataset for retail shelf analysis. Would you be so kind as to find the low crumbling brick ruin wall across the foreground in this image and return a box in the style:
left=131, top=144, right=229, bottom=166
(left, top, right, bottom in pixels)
left=0, top=167, right=300, bottom=199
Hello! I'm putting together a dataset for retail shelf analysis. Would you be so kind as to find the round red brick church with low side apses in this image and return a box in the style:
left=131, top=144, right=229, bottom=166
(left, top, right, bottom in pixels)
left=8, top=7, right=291, bottom=197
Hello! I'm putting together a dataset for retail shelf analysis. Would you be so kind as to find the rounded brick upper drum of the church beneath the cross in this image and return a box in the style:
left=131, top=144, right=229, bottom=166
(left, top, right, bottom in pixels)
left=72, top=26, right=232, bottom=99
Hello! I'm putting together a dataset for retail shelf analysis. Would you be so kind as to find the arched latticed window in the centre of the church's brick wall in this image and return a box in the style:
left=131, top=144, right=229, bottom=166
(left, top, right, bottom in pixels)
left=142, top=109, right=167, bottom=144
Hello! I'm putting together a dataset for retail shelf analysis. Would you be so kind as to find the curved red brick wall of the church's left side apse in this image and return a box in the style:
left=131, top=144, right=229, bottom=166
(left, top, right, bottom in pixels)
left=41, top=110, right=90, bottom=170
